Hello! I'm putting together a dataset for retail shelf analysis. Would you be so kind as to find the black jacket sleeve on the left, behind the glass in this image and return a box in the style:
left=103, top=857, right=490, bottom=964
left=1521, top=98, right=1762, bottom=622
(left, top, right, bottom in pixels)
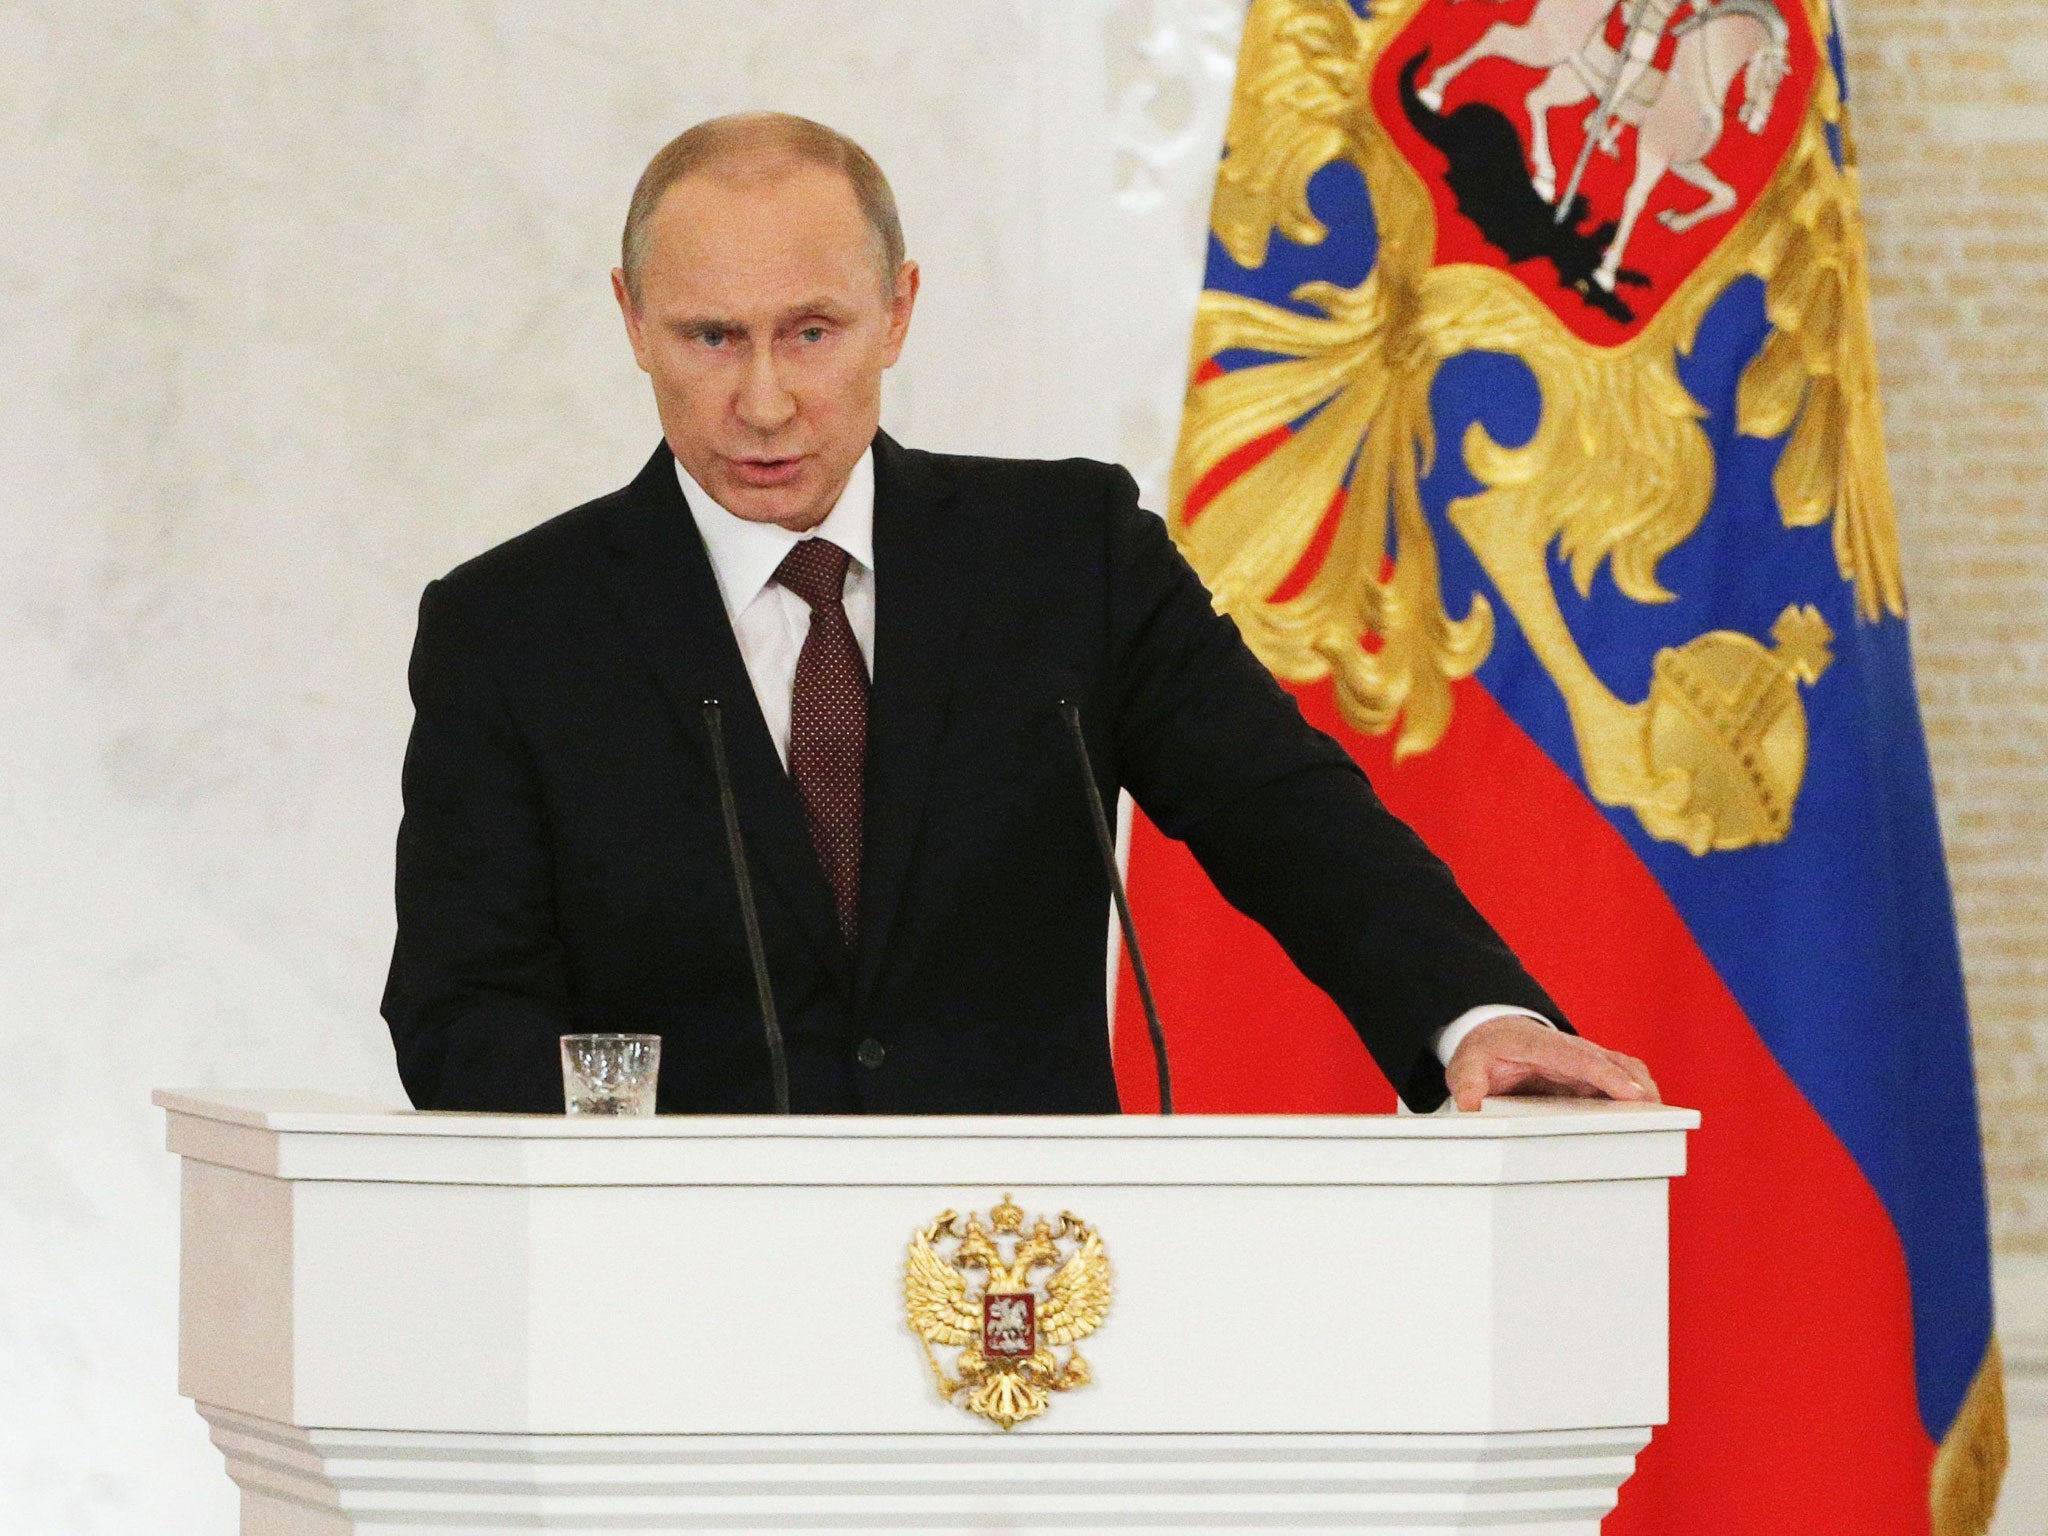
left=383, top=584, right=573, bottom=1112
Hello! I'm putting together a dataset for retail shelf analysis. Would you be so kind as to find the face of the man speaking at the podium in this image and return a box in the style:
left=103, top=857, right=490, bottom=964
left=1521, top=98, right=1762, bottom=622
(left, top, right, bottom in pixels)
left=612, top=158, right=918, bottom=530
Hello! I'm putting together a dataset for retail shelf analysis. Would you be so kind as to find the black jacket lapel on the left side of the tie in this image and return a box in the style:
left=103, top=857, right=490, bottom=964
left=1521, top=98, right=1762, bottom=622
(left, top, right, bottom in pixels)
left=602, top=444, right=852, bottom=991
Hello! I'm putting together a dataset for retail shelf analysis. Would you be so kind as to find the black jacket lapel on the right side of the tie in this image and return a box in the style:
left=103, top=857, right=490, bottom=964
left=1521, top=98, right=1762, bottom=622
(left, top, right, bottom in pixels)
left=854, top=434, right=975, bottom=1010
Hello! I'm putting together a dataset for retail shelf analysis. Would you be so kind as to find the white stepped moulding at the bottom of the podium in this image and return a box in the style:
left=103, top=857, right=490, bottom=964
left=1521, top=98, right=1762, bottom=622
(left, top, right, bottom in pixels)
left=199, top=1403, right=1649, bottom=1536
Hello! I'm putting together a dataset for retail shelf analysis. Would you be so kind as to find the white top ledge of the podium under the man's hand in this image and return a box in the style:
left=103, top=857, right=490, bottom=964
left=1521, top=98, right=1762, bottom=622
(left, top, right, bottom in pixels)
left=154, top=1090, right=1700, bottom=1186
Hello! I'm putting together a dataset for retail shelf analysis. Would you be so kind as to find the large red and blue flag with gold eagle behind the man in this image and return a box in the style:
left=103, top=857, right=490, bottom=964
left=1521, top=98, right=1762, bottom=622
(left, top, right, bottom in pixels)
left=1118, top=0, right=2005, bottom=1536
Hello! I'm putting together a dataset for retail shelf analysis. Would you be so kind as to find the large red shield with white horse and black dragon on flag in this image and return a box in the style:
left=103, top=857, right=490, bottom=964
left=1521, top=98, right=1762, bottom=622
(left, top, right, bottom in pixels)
left=1372, top=0, right=1819, bottom=346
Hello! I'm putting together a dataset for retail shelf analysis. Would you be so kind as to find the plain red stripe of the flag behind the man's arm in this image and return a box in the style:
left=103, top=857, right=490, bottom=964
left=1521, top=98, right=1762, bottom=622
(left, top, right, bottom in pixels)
left=1116, top=680, right=1933, bottom=1536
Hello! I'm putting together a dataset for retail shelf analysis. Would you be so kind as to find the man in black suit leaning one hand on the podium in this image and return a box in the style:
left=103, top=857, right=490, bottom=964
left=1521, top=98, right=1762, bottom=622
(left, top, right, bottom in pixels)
left=385, top=115, right=1655, bottom=1114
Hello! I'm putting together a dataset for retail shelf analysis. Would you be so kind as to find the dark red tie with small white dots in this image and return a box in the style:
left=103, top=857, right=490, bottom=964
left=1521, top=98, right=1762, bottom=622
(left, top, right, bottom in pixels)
left=774, top=539, right=868, bottom=948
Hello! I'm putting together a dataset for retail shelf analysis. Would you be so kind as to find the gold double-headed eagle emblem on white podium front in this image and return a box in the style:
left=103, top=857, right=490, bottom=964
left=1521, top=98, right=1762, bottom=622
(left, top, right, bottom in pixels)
left=903, top=1194, right=1110, bottom=1430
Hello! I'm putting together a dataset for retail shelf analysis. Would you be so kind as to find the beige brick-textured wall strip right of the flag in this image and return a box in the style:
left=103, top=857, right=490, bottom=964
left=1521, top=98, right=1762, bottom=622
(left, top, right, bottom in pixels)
left=1845, top=0, right=2048, bottom=1257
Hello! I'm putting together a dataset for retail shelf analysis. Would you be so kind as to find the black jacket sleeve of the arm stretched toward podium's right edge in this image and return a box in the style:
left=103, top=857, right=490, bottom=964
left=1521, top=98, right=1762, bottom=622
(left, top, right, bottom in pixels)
left=1108, top=469, right=1569, bottom=1110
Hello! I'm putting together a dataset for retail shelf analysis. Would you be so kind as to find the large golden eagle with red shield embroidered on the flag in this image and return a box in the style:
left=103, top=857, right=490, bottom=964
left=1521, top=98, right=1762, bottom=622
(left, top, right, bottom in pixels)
left=1169, top=0, right=1905, bottom=854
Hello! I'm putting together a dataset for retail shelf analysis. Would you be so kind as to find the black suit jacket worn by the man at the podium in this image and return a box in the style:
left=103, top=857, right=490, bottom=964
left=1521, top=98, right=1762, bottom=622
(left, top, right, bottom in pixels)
left=383, top=436, right=1561, bottom=1114
